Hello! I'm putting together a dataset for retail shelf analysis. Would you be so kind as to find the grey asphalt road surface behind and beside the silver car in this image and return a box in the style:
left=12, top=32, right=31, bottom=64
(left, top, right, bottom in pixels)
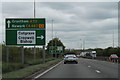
left=35, top=58, right=118, bottom=78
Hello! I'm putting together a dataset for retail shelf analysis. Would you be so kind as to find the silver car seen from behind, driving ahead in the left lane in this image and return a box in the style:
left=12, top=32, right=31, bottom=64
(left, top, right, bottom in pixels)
left=64, top=54, right=78, bottom=64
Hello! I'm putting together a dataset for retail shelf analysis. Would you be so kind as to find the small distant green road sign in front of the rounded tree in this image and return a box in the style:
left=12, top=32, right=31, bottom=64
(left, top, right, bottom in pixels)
left=49, top=46, right=63, bottom=54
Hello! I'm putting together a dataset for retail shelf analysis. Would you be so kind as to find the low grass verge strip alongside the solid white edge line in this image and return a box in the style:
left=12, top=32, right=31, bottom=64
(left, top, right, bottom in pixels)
left=2, top=59, right=61, bottom=78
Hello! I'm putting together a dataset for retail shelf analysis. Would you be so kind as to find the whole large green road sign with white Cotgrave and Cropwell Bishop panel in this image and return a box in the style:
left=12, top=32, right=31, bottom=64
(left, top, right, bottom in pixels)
left=6, top=18, right=46, bottom=46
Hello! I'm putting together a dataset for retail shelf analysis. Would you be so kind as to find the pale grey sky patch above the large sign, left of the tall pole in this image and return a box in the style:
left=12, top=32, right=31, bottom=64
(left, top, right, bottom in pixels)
left=2, top=2, right=33, bottom=17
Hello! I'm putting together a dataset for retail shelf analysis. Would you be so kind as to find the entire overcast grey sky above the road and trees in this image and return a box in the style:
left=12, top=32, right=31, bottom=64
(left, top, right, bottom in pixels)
left=0, top=2, right=118, bottom=49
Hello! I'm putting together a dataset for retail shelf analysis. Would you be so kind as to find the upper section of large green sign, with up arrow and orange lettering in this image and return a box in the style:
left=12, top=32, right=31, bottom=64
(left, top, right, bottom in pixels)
left=6, top=18, right=45, bottom=29
